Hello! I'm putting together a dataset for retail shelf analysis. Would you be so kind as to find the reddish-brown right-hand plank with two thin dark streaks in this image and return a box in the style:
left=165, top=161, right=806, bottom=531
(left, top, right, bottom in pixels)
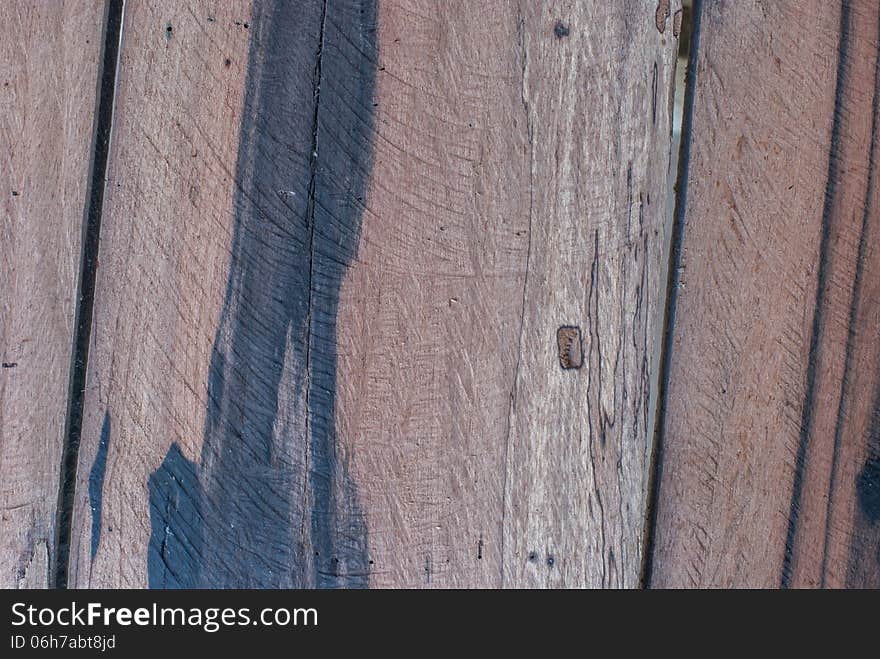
left=651, top=0, right=880, bottom=587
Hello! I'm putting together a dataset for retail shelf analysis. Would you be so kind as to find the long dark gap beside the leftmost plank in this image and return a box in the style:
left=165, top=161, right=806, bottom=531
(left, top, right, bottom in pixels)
left=49, top=0, right=125, bottom=588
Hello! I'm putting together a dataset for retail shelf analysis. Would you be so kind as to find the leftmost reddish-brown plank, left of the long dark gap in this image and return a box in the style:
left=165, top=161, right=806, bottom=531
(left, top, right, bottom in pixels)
left=0, top=0, right=104, bottom=588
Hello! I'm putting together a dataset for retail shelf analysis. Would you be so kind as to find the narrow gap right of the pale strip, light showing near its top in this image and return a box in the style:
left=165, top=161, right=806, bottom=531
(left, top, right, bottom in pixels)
left=640, top=0, right=702, bottom=588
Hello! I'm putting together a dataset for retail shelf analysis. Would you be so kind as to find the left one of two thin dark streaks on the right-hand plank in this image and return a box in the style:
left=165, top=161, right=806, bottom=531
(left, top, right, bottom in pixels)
left=780, top=0, right=851, bottom=588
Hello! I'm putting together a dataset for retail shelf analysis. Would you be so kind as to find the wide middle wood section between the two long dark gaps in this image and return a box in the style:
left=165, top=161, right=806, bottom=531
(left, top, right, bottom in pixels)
left=70, top=0, right=678, bottom=587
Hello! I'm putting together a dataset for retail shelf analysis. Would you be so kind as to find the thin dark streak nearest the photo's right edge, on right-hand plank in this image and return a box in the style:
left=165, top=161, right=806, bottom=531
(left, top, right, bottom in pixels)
left=820, top=9, right=880, bottom=587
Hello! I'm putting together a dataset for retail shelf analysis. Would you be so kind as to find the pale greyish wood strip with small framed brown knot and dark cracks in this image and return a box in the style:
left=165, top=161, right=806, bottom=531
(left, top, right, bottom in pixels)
left=504, top=2, right=681, bottom=587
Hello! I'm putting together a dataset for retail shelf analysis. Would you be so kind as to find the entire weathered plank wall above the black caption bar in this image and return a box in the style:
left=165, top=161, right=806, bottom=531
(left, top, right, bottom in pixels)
left=0, top=0, right=880, bottom=588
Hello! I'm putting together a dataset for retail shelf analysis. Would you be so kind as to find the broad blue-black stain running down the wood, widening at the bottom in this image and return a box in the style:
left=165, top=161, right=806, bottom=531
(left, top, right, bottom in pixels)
left=149, top=0, right=377, bottom=588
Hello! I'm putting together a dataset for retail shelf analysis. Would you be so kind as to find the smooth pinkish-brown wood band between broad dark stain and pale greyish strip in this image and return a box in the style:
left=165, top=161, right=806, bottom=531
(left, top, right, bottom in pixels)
left=337, top=1, right=528, bottom=587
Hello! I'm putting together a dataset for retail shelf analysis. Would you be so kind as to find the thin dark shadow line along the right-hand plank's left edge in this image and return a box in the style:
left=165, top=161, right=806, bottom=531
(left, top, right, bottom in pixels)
left=640, top=0, right=703, bottom=588
